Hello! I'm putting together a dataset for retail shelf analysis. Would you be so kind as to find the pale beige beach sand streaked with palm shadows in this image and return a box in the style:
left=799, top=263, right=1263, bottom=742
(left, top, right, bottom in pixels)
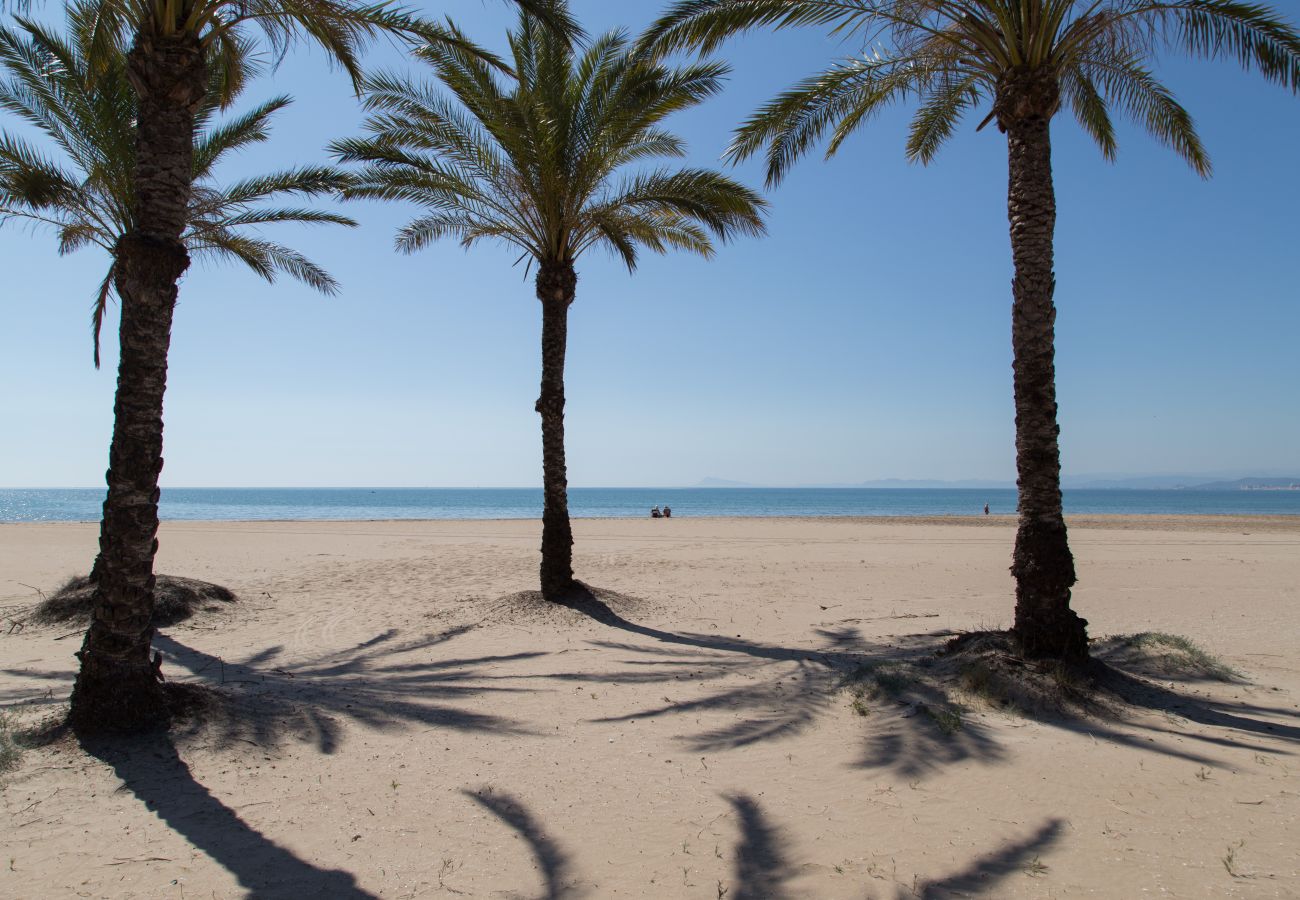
left=0, top=518, right=1300, bottom=900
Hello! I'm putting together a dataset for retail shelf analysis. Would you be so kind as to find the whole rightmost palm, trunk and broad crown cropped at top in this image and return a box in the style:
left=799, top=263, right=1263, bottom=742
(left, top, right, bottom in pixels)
left=646, top=0, right=1300, bottom=662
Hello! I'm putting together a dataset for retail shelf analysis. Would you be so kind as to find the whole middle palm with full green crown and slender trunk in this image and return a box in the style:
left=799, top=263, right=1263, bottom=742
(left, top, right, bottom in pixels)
left=334, top=12, right=766, bottom=601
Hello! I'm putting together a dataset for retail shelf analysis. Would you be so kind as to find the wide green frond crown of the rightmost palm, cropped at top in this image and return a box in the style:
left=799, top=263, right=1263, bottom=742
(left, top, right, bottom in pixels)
left=647, top=0, right=1300, bottom=182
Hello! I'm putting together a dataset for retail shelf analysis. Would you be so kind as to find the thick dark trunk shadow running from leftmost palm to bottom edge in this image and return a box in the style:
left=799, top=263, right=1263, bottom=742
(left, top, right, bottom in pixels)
left=81, top=732, right=376, bottom=900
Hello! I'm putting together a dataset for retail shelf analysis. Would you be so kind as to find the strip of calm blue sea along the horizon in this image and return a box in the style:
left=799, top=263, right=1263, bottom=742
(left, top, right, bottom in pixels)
left=0, top=488, right=1300, bottom=522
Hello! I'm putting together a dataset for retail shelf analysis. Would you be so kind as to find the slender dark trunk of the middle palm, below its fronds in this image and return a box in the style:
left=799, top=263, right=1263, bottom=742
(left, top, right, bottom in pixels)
left=536, top=261, right=577, bottom=601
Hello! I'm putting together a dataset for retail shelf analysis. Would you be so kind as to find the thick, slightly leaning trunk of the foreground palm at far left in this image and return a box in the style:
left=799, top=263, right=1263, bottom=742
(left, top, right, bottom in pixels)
left=72, top=33, right=208, bottom=732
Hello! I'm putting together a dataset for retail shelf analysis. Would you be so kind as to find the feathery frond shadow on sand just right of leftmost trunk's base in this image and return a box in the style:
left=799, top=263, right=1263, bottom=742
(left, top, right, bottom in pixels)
left=153, top=627, right=545, bottom=753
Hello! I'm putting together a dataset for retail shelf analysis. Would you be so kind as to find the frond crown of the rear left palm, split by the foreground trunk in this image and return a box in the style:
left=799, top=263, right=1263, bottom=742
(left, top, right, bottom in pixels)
left=0, top=8, right=356, bottom=367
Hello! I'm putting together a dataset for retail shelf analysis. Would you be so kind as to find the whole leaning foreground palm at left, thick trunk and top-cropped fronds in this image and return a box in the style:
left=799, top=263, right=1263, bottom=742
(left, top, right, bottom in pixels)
left=20, top=0, right=579, bottom=732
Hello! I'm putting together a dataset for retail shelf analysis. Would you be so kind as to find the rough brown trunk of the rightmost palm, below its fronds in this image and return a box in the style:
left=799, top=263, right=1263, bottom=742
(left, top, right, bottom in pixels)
left=997, top=72, right=1088, bottom=662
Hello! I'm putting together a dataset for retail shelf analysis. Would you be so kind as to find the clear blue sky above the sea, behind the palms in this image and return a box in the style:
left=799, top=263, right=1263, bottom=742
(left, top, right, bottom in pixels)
left=0, top=0, right=1300, bottom=486
